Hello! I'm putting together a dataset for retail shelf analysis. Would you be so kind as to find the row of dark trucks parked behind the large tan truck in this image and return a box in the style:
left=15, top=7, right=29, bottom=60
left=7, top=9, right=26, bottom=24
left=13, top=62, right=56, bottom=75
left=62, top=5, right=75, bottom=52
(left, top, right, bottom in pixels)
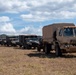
left=0, top=35, right=39, bottom=49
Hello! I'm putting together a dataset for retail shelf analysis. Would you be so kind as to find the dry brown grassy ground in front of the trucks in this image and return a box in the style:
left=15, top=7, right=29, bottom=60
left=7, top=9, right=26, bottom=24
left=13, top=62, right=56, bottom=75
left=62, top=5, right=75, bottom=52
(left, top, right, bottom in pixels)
left=0, top=46, right=76, bottom=75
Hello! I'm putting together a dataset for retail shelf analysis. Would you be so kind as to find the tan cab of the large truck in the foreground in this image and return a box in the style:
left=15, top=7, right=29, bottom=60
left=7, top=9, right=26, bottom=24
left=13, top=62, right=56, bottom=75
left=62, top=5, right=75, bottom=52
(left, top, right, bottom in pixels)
left=56, top=26, right=76, bottom=52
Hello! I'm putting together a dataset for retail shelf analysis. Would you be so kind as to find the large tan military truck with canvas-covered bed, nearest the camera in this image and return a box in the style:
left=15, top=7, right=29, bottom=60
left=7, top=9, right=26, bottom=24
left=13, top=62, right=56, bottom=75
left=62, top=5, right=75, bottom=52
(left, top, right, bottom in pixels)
left=37, top=23, right=76, bottom=56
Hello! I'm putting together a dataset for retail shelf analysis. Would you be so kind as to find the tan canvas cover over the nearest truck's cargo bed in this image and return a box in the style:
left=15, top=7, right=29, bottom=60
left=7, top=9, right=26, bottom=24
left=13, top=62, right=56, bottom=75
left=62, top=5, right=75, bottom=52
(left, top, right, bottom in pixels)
left=42, top=23, right=75, bottom=42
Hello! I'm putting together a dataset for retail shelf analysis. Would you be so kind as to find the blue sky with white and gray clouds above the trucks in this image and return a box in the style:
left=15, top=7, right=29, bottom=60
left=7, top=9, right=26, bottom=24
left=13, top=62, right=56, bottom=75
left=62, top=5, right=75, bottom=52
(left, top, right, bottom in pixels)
left=0, top=0, right=76, bottom=35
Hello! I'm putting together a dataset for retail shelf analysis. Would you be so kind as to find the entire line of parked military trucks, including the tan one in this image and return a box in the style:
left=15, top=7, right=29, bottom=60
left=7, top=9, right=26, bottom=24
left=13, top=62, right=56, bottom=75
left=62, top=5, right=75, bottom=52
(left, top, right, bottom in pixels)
left=0, top=23, right=76, bottom=56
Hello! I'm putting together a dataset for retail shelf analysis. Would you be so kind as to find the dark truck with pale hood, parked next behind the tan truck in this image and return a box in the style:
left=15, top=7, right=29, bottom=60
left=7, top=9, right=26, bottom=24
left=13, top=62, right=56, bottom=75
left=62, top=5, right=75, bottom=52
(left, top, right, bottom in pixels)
left=19, top=35, right=38, bottom=49
